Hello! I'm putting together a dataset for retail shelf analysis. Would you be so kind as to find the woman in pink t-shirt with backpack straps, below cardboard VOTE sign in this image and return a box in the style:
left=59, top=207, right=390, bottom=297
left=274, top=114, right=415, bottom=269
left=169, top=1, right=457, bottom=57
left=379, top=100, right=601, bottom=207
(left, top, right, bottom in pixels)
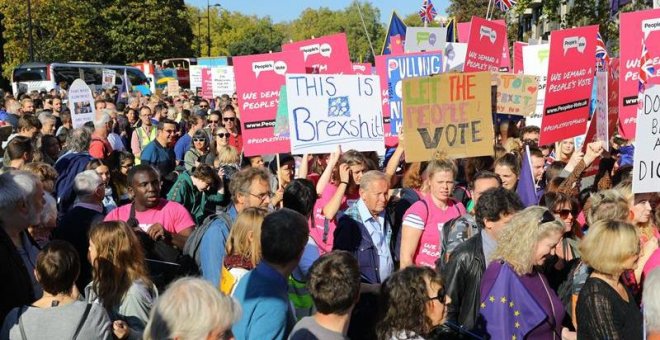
left=400, top=159, right=465, bottom=268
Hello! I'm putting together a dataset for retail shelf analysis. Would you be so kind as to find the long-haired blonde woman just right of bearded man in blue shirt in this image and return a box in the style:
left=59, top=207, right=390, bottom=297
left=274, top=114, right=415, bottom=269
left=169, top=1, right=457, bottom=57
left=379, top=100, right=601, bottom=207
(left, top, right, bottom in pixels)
left=220, top=207, right=268, bottom=295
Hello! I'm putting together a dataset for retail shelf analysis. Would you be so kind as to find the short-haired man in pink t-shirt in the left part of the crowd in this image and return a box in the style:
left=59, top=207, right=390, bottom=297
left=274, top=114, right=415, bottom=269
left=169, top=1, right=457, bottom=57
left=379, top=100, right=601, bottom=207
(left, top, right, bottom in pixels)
left=105, top=164, right=195, bottom=249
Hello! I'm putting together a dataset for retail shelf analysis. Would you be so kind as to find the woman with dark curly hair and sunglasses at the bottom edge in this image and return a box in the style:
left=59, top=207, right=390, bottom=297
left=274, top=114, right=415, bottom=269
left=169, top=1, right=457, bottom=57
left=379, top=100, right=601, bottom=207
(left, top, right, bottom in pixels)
left=376, top=267, right=451, bottom=340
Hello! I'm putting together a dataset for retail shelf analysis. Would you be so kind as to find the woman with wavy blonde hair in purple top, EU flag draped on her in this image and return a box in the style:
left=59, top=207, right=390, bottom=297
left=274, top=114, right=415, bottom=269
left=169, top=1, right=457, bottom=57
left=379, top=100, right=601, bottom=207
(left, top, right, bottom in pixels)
left=480, top=206, right=575, bottom=340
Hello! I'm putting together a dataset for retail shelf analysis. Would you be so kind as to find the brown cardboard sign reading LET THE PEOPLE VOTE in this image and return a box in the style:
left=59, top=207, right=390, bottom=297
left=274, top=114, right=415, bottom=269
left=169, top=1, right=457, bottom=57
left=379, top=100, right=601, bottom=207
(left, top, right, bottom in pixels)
left=403, top=72, right=495, bottom=162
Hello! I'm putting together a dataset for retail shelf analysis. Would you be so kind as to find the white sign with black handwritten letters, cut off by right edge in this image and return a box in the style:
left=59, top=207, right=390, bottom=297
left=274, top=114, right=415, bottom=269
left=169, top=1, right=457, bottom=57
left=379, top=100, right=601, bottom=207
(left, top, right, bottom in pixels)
left=633, top=85, right=660, bottom=194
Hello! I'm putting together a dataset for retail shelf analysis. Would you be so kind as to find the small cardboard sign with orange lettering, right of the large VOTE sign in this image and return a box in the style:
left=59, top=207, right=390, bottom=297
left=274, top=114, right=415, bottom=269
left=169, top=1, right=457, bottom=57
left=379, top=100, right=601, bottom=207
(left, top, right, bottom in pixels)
left=492, top=72, right=539, bottom=116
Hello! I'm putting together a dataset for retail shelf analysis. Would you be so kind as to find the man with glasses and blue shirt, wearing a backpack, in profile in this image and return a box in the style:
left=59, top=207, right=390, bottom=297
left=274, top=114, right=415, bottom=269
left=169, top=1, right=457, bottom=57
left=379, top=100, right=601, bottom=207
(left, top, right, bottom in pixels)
left=198, top=168, right=273, bottom=287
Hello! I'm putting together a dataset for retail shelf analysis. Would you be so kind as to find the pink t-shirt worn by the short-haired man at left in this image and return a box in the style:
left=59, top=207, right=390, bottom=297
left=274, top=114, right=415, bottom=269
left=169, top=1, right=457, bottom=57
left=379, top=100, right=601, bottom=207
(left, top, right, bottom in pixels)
left=104, top=198, right=195, bottom=234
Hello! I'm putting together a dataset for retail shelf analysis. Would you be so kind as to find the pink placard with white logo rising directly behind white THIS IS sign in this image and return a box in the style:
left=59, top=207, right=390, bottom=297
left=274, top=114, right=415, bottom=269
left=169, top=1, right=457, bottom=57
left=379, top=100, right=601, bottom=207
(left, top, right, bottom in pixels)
left=282, top=33, right=353, bottom=74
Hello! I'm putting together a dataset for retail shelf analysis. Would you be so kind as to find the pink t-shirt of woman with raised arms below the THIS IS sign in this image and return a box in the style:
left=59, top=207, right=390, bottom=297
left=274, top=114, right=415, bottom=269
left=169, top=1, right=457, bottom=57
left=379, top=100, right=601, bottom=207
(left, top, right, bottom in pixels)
left=309, top=183, right=360, bottom=255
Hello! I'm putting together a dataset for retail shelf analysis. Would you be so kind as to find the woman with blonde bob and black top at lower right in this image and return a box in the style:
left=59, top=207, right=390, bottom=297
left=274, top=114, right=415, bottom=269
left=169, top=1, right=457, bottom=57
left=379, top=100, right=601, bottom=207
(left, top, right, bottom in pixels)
left=576, top=220, right=643, bottom=339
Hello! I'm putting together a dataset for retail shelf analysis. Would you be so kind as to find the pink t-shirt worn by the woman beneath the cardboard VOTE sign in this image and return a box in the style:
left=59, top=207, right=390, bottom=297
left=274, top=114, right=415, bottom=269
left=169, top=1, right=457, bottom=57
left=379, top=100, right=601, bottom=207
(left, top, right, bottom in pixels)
left=402, top=194, right=465, bottom=268
